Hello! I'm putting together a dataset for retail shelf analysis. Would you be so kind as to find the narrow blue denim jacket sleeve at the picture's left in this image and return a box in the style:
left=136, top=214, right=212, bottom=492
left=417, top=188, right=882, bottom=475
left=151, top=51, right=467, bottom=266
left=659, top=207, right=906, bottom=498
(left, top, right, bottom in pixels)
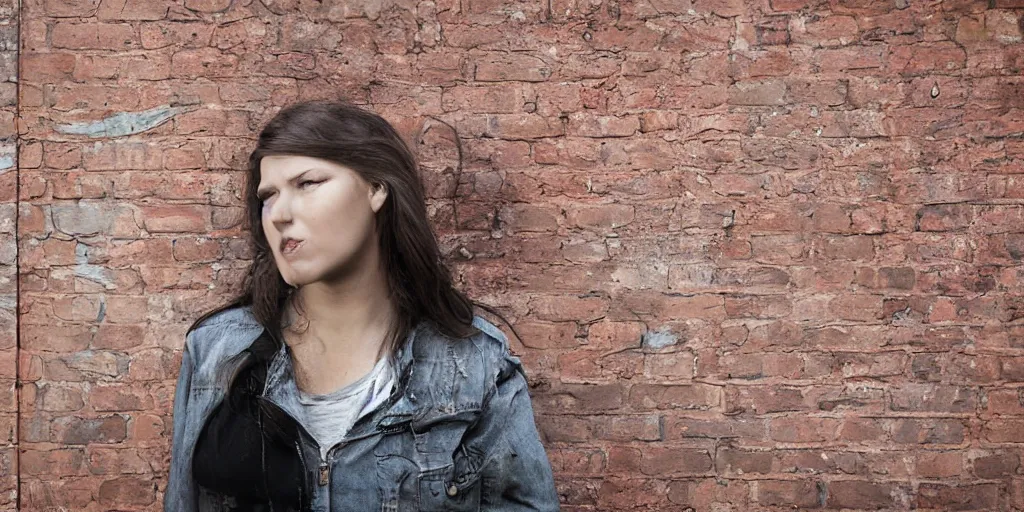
left=164, top=335, right=198, bottom=512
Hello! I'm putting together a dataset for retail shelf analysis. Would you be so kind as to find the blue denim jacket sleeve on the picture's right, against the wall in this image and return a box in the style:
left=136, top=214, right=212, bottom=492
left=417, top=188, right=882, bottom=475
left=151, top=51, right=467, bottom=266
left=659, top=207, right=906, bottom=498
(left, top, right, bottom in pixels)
left=480, top=354, right=559, bottom=512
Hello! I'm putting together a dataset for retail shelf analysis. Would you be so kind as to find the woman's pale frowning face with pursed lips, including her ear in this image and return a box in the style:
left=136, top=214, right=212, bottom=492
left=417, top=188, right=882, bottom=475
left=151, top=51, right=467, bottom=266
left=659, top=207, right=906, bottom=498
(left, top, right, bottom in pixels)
left=257, top=155, right=387, bottom=287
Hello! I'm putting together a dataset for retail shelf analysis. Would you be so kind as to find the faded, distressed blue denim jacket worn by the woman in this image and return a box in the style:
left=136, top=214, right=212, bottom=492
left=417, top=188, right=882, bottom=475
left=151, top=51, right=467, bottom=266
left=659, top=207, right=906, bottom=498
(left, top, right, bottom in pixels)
left=164, top=306, right=559, bottom=512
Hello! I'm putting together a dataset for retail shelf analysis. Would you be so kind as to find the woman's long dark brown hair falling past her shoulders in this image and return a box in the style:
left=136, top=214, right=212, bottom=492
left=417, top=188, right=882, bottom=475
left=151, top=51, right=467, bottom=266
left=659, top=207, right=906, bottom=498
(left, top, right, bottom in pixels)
left=188, top=100, right=515, bottom=354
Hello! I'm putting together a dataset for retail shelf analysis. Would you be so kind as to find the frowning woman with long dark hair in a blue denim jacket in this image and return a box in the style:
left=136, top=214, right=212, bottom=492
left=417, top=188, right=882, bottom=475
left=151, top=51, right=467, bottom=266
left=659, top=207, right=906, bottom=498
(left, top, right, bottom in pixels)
left=164, top=101, right=558, bottom=512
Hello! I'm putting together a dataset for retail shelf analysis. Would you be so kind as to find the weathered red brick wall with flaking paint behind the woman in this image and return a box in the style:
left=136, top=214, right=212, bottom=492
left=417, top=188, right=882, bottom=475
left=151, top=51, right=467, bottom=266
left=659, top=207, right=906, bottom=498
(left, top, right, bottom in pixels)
left=12, top=0, right=1024, bottom=512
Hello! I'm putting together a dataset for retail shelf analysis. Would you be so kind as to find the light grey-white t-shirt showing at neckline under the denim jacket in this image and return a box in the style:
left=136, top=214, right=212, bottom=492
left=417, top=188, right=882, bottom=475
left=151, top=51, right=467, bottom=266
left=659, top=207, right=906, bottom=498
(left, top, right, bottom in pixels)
left=299, top=356, right=394, bottom=460
